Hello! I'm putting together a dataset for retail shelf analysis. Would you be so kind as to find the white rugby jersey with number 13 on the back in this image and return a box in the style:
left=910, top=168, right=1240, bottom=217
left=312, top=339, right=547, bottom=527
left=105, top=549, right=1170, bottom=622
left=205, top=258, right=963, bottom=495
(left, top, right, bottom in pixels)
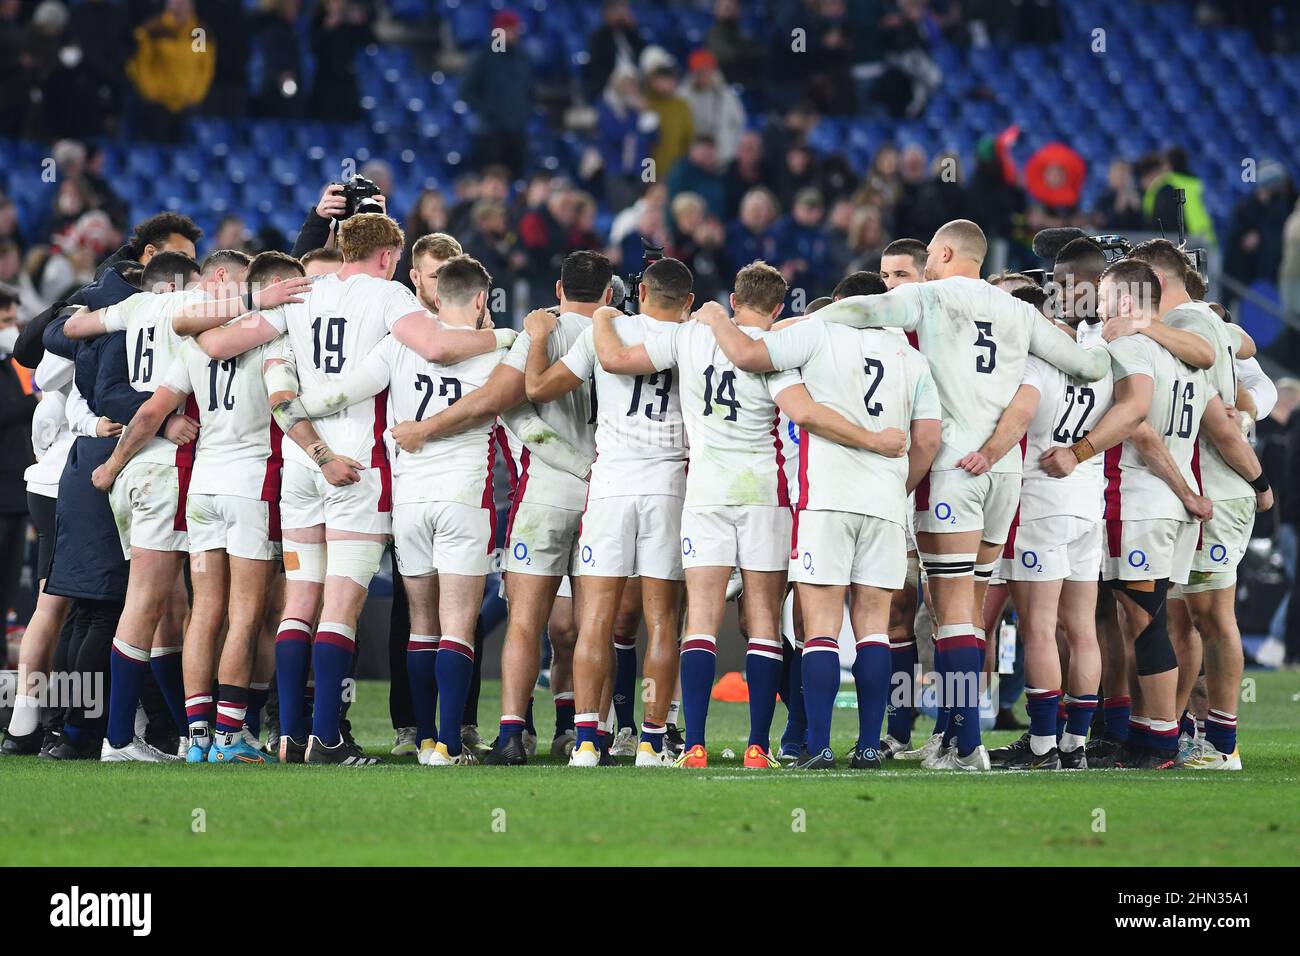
left=560, top=315, right=686, bottom=498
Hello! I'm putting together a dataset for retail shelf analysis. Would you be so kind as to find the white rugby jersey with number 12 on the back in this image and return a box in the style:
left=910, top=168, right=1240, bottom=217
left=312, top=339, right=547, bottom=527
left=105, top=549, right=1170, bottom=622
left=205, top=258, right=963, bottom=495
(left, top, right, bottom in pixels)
left=159, top=338, right=283, bottom=501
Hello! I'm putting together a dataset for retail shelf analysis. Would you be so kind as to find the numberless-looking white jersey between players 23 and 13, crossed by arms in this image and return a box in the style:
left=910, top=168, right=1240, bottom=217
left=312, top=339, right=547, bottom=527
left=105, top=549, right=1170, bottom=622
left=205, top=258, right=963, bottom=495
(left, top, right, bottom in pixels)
left=503, top=312, right=595, bottom=511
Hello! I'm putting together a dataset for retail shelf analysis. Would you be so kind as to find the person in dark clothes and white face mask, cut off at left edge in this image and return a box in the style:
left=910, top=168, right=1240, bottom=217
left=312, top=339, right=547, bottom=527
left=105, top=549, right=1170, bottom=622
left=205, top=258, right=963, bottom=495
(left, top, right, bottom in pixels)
left=0, top=286, right=36, bottom=615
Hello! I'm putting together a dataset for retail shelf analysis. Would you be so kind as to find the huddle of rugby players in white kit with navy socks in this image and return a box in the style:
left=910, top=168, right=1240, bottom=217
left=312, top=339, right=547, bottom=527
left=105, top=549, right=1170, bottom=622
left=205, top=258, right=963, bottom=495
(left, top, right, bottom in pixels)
left=10, top=205, right=1275, bottom=771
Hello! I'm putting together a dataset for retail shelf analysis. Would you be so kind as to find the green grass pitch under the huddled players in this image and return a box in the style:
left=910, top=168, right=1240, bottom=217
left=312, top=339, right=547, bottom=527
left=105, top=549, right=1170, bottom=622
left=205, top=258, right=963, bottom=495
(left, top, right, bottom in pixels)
left=0, top=672, right=1300, bottom=866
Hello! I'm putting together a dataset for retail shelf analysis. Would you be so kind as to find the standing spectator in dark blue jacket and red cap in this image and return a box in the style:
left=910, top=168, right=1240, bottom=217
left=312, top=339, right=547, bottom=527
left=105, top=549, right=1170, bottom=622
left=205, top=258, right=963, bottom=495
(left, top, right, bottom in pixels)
left=460, top=9, right=533, bottom=176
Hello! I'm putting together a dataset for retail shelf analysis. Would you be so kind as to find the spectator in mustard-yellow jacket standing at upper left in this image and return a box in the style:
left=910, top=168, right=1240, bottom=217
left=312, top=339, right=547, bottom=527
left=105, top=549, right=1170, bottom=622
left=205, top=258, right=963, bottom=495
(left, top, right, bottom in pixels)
left=126, top=0, right=214, bottom=143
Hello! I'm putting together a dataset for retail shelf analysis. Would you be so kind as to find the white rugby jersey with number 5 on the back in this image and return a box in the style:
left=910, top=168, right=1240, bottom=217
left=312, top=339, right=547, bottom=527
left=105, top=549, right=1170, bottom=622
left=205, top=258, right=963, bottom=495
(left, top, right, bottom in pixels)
left=818, top=276, right=1106, bottom=473
